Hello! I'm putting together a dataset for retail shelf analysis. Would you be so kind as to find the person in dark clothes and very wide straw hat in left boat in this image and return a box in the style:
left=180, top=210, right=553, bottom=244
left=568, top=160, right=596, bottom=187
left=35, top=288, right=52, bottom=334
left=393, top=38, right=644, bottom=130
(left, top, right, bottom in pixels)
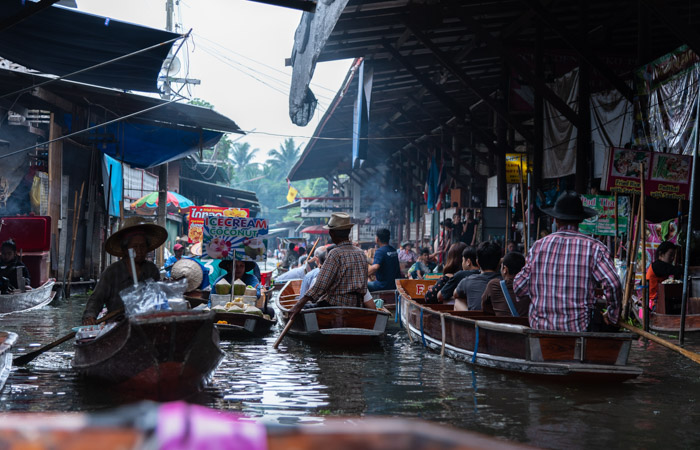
left=83, top=216, right=168, bottom=325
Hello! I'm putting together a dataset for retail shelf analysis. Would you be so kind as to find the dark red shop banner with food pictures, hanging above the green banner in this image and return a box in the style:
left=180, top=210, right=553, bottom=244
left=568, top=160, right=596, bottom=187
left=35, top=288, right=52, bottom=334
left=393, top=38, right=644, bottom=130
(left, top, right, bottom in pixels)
left=601, top=147, right=692, bottom=200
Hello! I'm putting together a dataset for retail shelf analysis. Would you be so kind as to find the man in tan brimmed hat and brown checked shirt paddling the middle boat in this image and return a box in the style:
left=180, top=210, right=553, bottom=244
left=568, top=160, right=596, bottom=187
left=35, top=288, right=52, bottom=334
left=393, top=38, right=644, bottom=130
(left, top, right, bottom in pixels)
left=290, top=213, right=374, bottom=315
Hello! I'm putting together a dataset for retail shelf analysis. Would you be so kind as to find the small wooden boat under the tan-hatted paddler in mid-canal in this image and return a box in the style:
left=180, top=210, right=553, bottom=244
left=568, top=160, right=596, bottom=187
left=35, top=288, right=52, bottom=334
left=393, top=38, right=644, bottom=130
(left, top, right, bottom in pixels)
left=275, top=280, right=390, bottom=345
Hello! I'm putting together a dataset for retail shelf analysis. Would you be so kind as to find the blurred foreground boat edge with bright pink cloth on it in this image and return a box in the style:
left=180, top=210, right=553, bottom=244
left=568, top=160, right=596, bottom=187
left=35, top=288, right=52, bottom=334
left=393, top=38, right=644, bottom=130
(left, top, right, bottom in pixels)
left=0, top=402, right=529, bottom=450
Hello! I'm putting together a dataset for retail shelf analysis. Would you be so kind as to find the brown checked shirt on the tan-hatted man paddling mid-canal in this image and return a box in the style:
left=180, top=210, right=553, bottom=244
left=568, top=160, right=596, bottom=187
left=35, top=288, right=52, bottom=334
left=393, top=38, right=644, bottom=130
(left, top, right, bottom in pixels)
left=306, top=241, right=368, bottom=306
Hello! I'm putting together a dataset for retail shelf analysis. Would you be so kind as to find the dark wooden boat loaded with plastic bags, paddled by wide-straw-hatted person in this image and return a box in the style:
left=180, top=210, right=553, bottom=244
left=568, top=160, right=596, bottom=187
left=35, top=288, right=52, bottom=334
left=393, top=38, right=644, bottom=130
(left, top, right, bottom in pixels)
left=73, top=311, right=223, bottom=400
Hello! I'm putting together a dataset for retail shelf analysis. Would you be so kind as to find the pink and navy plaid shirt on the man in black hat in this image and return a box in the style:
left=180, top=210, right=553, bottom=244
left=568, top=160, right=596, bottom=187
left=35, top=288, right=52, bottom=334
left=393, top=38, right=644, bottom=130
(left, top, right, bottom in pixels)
left=513, top=227, right=622, bottom=332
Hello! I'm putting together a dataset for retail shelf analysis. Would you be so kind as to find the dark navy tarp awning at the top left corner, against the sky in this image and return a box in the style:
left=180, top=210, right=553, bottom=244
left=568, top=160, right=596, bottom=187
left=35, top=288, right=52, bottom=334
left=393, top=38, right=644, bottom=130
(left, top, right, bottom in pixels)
left=0, top=1, right=180, bottom=92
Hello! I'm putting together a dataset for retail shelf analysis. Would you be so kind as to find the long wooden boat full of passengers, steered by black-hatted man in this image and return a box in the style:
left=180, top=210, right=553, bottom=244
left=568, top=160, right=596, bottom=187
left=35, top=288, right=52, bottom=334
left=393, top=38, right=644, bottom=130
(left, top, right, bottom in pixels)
left=397, top=280, right=642, bottom=381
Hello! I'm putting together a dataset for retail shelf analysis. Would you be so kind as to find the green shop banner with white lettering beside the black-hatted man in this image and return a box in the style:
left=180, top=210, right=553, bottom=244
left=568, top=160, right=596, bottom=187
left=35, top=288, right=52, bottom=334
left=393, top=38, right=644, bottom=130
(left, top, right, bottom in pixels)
left=578, top=195, right=629, bottom=236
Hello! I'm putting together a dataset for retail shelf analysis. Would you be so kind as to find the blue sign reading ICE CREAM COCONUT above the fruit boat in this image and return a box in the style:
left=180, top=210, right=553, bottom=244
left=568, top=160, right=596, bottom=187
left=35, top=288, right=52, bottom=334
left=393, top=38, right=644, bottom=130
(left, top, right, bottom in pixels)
left=202, top=216, right=267, bottom=261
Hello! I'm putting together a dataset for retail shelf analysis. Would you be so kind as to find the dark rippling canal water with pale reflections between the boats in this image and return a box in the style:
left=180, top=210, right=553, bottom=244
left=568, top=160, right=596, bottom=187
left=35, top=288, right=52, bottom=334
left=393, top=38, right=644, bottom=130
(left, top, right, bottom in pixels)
left=0, top=297, right=700, bottom=448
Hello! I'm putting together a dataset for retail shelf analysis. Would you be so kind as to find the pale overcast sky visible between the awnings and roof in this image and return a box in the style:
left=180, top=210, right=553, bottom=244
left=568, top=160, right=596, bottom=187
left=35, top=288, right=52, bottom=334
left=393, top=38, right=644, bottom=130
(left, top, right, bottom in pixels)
left=77, top=0, right=350, bottom=161
